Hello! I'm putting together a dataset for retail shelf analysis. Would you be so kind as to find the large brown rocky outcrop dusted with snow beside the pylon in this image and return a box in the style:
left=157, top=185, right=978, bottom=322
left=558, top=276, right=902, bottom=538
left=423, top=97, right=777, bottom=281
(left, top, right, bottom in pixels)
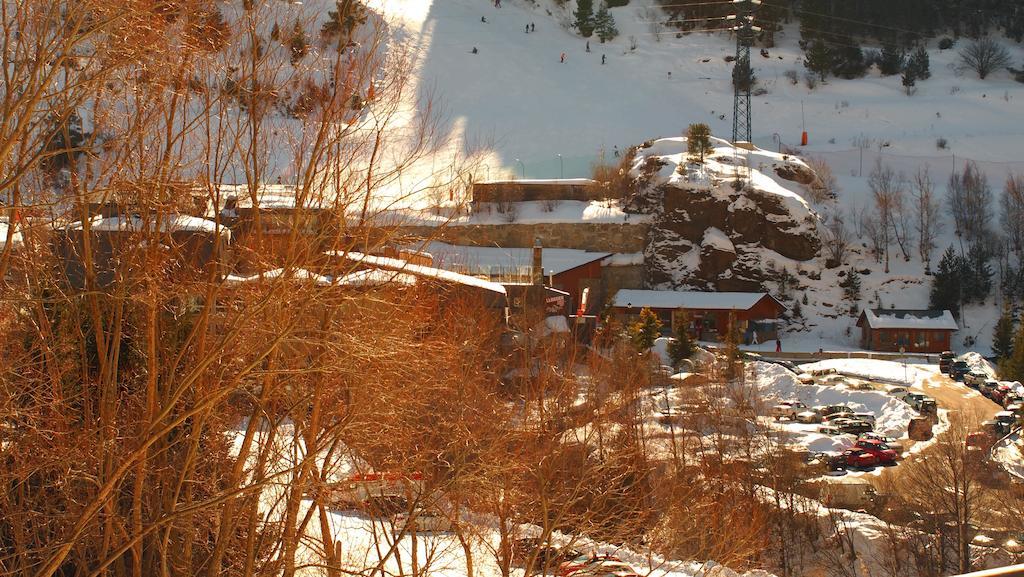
left=633, top=138, right=820, bottom=290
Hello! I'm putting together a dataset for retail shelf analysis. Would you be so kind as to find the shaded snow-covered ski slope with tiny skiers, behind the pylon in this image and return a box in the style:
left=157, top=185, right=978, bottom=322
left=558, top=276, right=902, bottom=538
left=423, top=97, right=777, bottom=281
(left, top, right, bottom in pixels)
left=387, top=0, right=1024, bottom=181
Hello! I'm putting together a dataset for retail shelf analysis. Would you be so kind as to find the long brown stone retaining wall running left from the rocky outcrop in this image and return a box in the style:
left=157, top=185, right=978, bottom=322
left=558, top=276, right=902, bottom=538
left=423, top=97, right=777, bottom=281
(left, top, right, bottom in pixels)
left=397, top=222, right=650, bottom=252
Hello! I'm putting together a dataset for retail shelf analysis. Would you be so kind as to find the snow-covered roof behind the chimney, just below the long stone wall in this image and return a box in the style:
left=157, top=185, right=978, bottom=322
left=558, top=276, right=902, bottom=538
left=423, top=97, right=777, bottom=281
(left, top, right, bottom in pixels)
left=405, top=242, right=612, bottom=276
